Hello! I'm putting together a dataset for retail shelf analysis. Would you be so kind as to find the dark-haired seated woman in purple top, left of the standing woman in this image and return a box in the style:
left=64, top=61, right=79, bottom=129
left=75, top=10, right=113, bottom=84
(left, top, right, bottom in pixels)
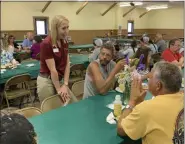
left=31, top=35, right=42, bottom=59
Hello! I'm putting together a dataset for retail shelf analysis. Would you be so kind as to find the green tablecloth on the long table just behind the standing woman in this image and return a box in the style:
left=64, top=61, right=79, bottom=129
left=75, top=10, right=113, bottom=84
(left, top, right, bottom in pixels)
left=0, top=54, right=89, bottom=84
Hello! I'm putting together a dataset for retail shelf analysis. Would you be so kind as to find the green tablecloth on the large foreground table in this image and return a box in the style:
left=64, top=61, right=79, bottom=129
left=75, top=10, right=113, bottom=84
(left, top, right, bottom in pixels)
left=29, top=92, right=151, bottom=144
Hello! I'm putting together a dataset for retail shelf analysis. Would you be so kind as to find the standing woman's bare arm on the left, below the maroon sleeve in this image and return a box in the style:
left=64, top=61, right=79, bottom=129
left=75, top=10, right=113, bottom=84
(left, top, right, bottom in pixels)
left=46, top=58, right=60, bottom=92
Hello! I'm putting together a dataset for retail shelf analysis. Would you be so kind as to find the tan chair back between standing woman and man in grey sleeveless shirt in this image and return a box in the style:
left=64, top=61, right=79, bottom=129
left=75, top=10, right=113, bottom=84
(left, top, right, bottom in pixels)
left=71, top=80, right=84, bottom=100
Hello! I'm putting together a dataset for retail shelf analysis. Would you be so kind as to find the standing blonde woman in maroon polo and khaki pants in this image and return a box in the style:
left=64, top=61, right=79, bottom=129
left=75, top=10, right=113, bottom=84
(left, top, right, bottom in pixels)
left=37, top=15, right=76, bottom=103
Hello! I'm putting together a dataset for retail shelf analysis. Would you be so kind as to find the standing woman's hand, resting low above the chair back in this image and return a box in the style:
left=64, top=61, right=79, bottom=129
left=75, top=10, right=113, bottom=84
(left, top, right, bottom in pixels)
left=58, top=85, right=70, bottom=103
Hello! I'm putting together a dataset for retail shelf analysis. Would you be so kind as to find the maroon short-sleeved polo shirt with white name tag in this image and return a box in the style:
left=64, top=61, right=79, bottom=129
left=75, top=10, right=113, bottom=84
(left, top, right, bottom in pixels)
left=40, top=36, right=68, bottom=77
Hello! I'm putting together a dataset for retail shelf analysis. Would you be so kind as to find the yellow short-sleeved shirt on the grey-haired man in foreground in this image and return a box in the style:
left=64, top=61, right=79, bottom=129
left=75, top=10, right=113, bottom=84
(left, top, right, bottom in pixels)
left=121, top=93, right=184, bottom=144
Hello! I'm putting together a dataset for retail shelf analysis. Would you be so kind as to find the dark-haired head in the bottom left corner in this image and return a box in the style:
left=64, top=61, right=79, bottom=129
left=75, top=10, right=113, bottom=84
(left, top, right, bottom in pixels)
left=0, top=113, right=37, bottom=144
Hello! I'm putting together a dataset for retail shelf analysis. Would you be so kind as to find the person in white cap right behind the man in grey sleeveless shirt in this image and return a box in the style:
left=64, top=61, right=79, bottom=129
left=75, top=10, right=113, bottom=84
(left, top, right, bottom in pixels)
left=89, top=39, right=103, bottom=62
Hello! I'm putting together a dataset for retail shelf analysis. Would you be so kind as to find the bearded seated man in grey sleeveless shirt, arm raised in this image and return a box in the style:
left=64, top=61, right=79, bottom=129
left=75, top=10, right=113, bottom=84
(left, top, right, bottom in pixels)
left=83, top=42, right=126, bottom=98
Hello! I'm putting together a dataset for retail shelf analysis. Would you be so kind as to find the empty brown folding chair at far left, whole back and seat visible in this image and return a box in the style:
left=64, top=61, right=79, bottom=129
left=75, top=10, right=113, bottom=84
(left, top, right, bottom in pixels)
left=3, top=74, right=31, bottom=107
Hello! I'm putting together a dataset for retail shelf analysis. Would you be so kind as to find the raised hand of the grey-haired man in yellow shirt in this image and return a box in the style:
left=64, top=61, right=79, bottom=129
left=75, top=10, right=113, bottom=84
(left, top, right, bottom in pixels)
left=129, top=77, right=147, bottom=106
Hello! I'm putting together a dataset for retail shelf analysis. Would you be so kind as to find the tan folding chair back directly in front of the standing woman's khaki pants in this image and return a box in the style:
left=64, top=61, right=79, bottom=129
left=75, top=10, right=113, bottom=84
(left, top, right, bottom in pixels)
left=41, top=95, right=64, bottom=112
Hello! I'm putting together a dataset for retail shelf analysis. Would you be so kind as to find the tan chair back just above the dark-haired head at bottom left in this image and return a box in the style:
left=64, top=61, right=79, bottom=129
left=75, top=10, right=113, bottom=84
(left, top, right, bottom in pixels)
left=15, top=107, right=42, bottom=118
